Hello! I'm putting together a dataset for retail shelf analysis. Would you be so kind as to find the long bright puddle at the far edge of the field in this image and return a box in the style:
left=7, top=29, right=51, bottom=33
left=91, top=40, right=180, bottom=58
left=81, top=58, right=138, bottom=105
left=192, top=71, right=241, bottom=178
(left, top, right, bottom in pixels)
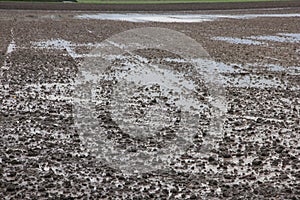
left=75, top=13, right=300, bottom=23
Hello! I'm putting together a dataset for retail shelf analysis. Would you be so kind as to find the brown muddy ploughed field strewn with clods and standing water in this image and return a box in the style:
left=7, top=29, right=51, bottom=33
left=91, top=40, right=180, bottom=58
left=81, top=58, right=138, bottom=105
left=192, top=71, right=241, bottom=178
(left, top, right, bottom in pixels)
left=0, top=7, right=300, bottom=199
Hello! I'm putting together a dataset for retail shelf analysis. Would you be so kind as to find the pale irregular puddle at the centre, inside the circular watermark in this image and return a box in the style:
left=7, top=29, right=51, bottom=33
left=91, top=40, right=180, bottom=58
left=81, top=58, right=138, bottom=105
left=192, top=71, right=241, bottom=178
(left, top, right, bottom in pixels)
left=109, top=56, right=207, bottom=111
